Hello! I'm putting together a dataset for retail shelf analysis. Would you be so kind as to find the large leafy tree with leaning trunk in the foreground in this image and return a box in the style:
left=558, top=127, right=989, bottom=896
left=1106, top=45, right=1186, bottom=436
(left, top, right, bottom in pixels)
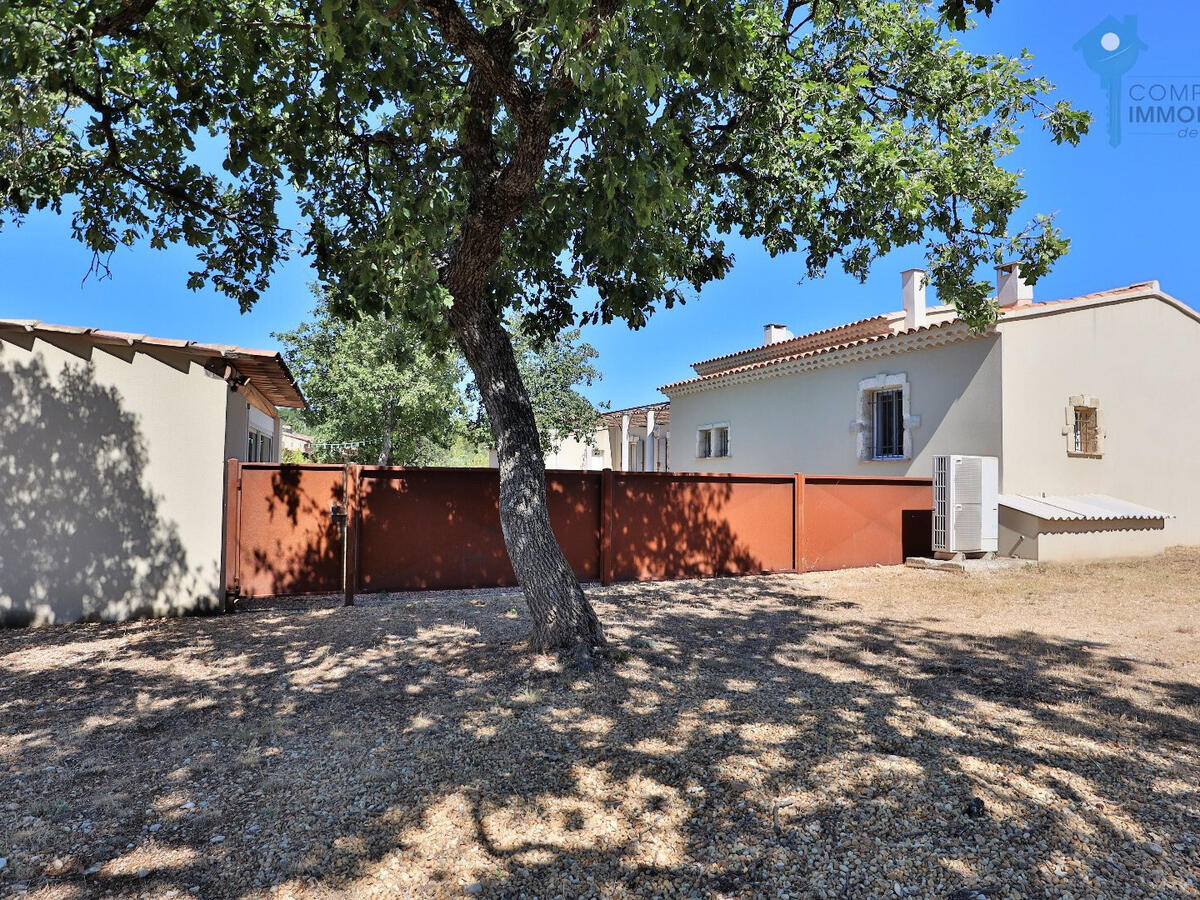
left=0, top=0, right=1086, bottom=649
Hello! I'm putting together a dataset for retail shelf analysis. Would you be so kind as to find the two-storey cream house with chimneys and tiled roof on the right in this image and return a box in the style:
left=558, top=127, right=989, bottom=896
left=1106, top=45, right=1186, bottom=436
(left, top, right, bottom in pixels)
left=661, top=264, right=1200, bottom=560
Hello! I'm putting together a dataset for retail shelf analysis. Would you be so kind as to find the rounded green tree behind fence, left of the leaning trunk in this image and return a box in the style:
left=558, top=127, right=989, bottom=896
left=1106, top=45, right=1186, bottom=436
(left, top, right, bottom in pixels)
left=275, top=293, right=466, bottom=466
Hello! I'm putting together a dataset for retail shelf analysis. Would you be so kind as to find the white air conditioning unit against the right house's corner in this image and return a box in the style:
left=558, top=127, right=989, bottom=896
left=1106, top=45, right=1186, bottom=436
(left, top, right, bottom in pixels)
left=934, top=456, right=1000, bottom=553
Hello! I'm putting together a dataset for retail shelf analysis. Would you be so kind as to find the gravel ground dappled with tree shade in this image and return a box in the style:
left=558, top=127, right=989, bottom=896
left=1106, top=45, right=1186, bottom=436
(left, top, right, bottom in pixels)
left=0, top=551, right=1200, bottom=900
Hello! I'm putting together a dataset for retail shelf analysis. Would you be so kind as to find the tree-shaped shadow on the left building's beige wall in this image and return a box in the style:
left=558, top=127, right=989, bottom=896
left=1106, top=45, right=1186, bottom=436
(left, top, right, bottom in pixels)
left=0, top=359, right=187, bottom=625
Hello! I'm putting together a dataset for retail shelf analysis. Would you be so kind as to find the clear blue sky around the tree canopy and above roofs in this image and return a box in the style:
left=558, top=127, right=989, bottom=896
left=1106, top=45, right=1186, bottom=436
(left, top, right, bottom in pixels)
left=0, top=0, right=1200, bottom=407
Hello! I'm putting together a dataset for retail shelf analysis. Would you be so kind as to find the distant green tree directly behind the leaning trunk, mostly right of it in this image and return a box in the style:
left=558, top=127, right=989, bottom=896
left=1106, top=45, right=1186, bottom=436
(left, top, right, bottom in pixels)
left=467, top=317, right=600, bottom=452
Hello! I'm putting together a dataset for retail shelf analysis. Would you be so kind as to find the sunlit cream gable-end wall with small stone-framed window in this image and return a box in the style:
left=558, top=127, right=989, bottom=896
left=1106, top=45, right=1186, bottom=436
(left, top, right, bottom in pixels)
left=1000, top=298, right=1200, bottom=549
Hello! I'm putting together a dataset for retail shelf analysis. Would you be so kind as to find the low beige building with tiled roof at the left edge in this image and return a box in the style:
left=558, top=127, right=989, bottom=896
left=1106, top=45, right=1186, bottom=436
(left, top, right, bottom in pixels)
left=0, top=319, right=305, bottom=624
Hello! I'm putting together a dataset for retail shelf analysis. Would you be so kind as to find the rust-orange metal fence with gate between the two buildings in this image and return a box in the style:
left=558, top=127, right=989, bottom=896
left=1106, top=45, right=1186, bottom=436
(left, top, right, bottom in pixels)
left=222, top=460, right=931, bottom=598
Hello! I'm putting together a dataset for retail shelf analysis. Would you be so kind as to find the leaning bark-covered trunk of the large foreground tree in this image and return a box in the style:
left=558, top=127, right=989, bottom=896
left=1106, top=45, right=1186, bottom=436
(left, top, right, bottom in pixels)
left=450, top=292, right=605, bottom=658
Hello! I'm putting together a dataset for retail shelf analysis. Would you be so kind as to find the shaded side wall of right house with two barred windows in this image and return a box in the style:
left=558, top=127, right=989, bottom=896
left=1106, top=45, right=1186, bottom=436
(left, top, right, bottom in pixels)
left=671, top=336, right=1002, bottom=478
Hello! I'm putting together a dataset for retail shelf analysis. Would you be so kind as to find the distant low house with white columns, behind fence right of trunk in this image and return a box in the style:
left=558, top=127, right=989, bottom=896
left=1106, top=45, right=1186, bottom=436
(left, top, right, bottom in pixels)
left=487, top=402, right=671, bottom=472
